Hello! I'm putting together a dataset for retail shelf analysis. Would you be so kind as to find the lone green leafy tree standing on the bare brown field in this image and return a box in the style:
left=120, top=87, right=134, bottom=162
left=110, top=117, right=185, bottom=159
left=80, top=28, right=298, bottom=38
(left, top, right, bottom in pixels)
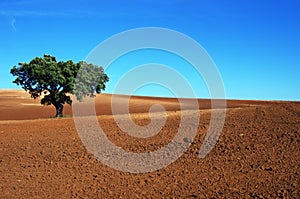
left=10, top=55, right=109, bottom=117
